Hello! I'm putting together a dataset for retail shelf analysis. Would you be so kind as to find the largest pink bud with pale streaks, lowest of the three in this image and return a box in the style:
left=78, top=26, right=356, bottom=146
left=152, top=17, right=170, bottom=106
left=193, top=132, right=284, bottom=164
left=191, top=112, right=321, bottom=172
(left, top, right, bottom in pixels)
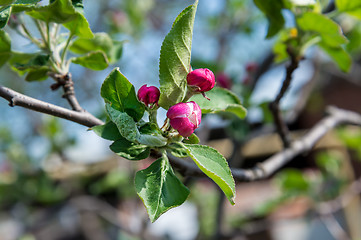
left=167, top=101, right=202, bottom=137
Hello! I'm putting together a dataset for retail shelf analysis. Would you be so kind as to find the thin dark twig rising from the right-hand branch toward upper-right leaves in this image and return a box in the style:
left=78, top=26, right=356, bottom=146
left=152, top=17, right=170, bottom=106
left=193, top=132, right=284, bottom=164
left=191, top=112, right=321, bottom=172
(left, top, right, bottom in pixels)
left=269, top=49, right=299, bottom=148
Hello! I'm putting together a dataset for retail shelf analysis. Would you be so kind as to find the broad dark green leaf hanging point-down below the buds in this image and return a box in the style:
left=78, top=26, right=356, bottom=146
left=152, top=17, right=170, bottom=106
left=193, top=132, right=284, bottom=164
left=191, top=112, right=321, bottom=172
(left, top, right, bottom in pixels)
left=135, top=156, right=189, bottom=222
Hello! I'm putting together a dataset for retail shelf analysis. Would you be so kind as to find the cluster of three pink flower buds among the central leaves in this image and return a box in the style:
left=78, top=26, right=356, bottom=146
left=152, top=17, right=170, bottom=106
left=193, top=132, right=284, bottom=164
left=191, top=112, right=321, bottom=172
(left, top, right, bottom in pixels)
left=138, top=68, right=215, bottom=137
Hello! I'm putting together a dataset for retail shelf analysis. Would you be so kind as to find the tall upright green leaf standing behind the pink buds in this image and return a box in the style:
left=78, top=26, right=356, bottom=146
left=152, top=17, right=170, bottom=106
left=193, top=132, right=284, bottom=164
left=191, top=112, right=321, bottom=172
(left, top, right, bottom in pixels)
left=159, top=0, right=198, bottom=109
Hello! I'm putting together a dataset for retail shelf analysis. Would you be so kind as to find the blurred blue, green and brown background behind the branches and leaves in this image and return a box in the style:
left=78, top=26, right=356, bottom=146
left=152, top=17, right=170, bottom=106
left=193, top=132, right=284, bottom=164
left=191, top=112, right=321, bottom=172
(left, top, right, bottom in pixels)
left=0, top=0, right=361, bottom=240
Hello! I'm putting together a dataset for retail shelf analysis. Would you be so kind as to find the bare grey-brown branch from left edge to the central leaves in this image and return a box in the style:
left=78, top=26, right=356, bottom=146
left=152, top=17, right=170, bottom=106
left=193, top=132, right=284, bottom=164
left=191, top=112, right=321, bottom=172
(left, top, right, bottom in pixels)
left=0, top=85, right=104, bottom=127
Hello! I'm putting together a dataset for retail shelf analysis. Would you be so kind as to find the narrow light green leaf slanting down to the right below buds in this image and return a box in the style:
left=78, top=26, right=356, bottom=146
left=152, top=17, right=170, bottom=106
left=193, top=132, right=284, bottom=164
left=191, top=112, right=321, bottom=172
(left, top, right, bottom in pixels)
left=184, top=144, right=236, bottom=205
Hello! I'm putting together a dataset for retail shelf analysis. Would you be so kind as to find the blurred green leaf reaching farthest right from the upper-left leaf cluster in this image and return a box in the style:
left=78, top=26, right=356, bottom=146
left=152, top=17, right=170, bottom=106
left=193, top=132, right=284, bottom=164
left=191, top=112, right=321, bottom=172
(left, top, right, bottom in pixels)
left=69, top=33, right=123, bottom=63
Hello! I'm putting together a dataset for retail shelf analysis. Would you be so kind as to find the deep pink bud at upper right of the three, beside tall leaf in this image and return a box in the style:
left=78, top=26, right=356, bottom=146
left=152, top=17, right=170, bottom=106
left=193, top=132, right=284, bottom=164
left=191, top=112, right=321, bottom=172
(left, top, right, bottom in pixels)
left=187, top=68, right=216, bottom=92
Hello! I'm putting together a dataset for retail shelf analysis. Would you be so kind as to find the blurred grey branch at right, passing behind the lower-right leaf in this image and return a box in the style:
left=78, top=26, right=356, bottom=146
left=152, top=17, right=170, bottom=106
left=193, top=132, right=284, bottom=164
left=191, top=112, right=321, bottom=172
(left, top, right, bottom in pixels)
left=169, top=107, right=361, bottom=181
